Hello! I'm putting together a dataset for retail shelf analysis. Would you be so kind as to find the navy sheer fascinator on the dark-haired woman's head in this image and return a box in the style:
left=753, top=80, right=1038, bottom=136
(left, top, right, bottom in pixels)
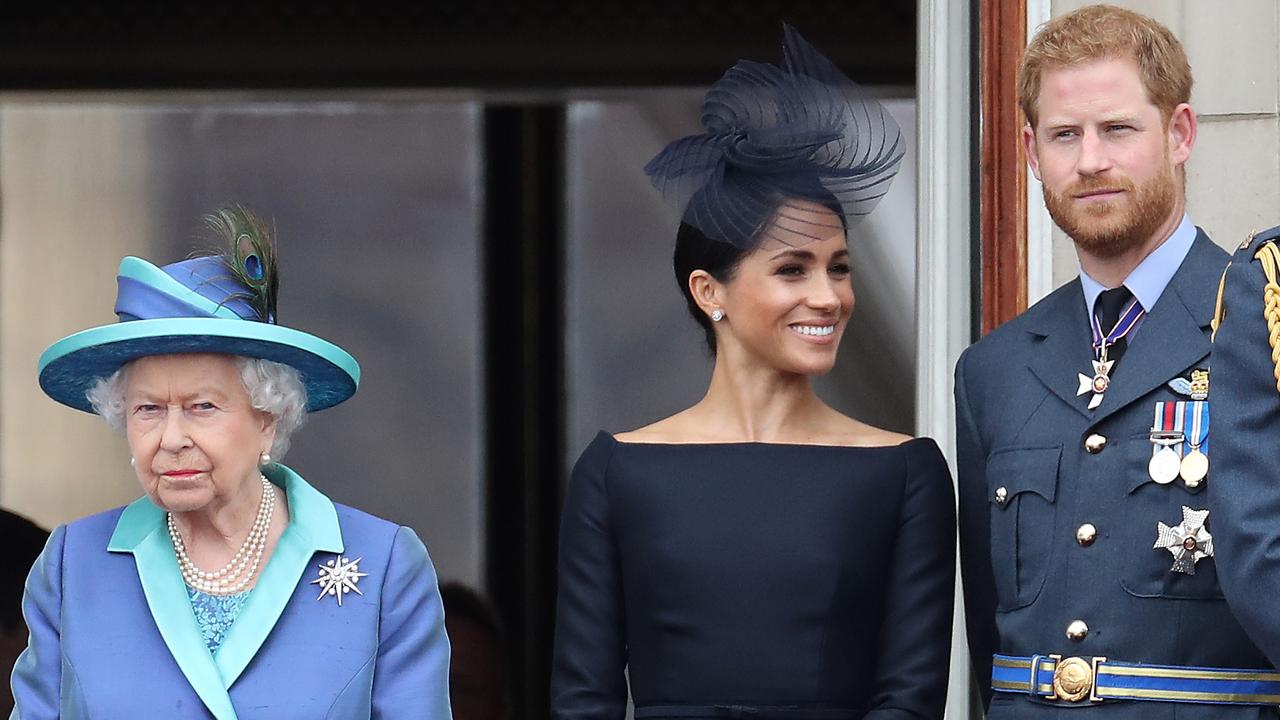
left=645, top=24, right=904, bottom=250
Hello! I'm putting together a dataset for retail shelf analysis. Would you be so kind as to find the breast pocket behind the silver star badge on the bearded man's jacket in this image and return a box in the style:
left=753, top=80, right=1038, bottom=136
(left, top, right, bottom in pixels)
left=1117, top=434, right=1222, bottom=600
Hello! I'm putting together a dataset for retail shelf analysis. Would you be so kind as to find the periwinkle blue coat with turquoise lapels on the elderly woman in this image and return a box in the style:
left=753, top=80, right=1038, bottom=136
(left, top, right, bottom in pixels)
left=5, top=466, right=449, bottom=720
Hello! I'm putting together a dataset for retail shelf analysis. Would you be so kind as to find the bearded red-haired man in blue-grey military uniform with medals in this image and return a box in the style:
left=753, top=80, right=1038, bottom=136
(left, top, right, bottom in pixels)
left=956, top=5, right=1280, bottom=720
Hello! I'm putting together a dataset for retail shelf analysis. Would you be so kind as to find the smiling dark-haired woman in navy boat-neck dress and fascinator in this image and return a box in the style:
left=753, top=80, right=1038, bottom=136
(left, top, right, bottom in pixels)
left=552, top=28, right=955, bottom=720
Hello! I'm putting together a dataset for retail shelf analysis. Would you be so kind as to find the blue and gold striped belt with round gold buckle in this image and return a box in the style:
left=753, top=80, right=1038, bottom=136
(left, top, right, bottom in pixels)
left=991, top=653, right=1280, bottom=705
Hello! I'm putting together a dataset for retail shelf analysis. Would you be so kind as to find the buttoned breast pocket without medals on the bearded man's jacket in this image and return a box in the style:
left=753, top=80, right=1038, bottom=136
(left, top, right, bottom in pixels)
left=987, top=446, right=1062, bottom=610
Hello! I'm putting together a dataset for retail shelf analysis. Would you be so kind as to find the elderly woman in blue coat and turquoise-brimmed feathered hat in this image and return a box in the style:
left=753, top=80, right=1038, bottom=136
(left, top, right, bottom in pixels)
left=13, top=209, right=449, bottom=720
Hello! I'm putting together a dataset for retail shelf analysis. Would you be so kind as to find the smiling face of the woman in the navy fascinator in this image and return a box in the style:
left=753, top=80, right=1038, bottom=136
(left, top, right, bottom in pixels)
left=717, top=202, right=854, bottom=375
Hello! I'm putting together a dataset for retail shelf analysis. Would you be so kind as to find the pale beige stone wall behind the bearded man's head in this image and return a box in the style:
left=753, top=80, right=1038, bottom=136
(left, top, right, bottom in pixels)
left=1049, top=0, right=1280, bottom=287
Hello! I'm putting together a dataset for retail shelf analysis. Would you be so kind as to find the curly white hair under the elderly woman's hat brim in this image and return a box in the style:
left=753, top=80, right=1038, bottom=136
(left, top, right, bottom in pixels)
left=84, top=355, right=307, bottom=462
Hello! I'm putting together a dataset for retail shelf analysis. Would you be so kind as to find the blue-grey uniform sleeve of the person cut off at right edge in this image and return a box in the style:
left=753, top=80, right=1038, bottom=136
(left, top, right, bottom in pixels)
left=1208, top=222, right=1280, bottom=664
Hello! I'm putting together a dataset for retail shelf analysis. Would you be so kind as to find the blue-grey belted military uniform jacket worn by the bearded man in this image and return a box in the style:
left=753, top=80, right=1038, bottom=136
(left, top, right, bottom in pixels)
left=955, top=219, right=1280, bottom=720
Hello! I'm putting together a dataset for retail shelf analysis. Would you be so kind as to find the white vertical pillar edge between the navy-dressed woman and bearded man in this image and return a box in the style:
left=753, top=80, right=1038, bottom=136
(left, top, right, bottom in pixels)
left=915, top=0, right=973, bottom=720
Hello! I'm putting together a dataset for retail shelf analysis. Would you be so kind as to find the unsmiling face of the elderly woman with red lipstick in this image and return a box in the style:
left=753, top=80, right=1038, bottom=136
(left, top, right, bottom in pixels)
left=124, top=355, right=275, bottom=512
